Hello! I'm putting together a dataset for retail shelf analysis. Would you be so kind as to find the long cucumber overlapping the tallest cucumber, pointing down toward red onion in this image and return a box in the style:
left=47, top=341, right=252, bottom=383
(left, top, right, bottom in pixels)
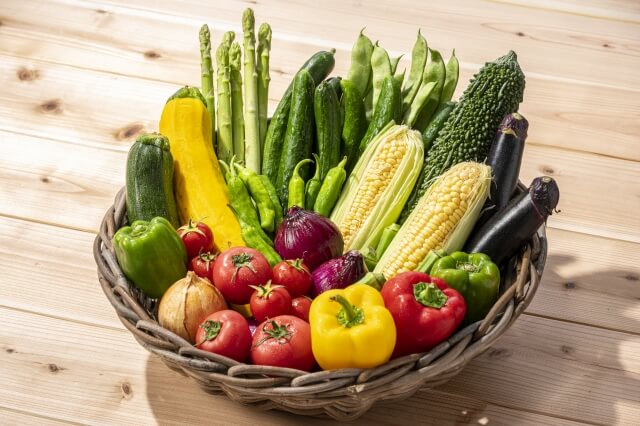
left=276, top=70, right=315, bottom=206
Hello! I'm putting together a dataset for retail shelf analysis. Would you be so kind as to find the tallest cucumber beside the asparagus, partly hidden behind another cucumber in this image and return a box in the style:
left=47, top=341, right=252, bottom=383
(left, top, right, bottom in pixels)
left=262, top=49, right=335, bottom=185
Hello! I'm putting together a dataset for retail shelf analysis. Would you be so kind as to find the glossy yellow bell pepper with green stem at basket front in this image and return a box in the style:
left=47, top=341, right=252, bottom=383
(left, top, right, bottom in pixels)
left=309, top=284, right=396, bottom=370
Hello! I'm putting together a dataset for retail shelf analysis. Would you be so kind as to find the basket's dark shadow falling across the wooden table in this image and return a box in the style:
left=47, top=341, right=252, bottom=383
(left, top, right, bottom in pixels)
left=146, top=255, right=640, bottom=425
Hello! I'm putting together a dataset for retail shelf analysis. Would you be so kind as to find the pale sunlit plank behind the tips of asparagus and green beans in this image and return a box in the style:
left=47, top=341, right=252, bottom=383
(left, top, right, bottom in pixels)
left=85, top=0, right=640, bottom=90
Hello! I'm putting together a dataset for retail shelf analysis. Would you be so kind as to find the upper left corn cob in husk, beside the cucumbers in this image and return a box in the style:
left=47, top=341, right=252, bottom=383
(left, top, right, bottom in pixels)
left=331, top=124, right=424, bottom=251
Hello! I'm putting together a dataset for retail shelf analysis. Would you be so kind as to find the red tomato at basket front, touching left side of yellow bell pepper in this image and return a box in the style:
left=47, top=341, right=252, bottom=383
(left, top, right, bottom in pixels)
left=250, top=315, right=316, bottom=371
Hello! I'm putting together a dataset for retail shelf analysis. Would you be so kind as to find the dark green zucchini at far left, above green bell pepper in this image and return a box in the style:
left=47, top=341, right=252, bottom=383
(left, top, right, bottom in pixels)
left=126, top=133, right=180, bottom=228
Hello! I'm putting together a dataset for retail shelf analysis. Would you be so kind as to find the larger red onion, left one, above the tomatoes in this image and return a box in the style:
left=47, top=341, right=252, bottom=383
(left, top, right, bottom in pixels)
left=274, top=206, right=344, bottom=270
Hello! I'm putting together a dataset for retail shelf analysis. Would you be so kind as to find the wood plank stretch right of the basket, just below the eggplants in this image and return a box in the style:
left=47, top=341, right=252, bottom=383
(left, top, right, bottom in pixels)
left=527, top=228, right=640, bottom=334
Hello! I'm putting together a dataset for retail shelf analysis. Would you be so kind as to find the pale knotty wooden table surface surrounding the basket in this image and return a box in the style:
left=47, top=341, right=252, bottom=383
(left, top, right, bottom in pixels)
left=0, top=0, right=640, bottom=425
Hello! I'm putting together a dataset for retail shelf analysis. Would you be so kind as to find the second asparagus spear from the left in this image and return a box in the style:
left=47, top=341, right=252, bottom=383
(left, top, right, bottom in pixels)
left=216, top=42, right=233, bottom=162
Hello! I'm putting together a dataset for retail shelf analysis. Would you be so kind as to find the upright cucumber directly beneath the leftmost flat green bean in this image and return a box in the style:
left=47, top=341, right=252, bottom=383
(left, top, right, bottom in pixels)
left=340, top=80, right=368, bottom=174
